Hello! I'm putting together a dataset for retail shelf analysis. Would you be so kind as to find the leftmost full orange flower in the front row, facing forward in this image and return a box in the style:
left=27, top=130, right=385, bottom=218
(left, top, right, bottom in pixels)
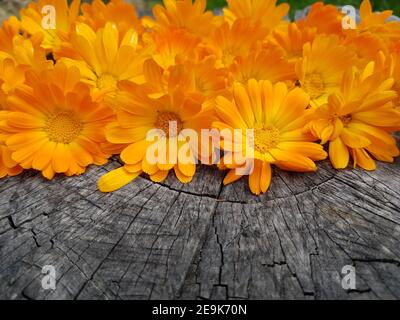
left=0, top=64, right=112, bottom=179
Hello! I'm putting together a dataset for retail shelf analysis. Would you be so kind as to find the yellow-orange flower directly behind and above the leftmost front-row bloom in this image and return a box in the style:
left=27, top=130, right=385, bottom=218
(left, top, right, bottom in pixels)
left=60, top=23, right=149, bottom=108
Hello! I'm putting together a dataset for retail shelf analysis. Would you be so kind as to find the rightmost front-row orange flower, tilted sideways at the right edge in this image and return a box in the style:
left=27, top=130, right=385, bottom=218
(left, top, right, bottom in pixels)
left=309, top=62, right=400, bottom=170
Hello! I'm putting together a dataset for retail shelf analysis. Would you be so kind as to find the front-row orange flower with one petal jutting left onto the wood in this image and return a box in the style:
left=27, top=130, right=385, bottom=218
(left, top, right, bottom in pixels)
left=98, top=77, right=210, bottom=192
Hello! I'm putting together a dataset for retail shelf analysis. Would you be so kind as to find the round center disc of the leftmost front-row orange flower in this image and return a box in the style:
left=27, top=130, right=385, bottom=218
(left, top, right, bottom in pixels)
left=45, top=112, right=83, bottom=144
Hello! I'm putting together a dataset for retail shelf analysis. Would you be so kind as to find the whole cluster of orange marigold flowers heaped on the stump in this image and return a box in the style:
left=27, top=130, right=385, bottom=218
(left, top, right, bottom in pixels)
left=0, top=0, right=400, bottom=194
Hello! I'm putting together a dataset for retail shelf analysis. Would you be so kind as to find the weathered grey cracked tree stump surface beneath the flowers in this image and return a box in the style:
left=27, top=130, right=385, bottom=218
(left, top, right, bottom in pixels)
left=0, top=137, right=400, bottom=299
